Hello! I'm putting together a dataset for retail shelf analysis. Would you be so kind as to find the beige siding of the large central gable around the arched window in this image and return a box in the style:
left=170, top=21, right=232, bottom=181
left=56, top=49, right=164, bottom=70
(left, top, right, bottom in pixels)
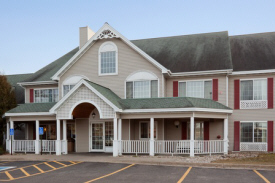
left=59, top=38, right=163, bottom=98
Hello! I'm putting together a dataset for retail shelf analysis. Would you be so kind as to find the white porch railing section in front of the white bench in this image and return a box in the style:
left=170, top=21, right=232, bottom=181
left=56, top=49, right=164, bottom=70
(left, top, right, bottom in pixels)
left=154, top=140, right=190, bottom=154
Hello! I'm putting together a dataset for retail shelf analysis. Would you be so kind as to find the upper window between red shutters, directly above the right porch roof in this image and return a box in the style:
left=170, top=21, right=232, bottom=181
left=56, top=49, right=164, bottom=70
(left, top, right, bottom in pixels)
left=179, top=80, right=212, bottom=99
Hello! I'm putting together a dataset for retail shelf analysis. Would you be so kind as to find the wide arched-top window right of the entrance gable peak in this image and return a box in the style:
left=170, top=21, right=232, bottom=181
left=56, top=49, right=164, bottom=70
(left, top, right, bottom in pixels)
left=125, top=71, right=159, bottom=98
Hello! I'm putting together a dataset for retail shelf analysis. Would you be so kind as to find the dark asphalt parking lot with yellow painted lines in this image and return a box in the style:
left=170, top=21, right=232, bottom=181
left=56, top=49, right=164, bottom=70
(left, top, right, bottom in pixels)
left=0, top=161, right=275, bottom=183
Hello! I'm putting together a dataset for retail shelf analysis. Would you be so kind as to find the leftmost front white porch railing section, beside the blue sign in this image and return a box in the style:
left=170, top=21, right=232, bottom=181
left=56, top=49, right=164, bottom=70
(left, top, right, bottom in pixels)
left=12, top=140, right=35, bottom=153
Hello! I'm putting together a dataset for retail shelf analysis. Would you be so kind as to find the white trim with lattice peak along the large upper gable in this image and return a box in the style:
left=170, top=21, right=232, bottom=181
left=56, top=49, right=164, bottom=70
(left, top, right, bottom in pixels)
left=51, top=23, right=169, bottom=80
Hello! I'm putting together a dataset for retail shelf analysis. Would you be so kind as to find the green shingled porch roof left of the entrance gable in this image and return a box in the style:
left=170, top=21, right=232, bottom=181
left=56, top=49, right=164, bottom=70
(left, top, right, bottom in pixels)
left=6, top=102, right=56, bottom=113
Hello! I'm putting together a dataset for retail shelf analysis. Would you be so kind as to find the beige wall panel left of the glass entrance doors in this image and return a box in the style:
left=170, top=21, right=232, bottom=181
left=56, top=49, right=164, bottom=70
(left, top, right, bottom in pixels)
left=75, top=119, right=89, bottom=152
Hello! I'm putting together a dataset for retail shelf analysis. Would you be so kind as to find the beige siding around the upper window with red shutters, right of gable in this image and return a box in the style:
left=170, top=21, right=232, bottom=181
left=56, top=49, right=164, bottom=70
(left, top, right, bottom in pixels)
left=166, top=75, right=229, bottom=105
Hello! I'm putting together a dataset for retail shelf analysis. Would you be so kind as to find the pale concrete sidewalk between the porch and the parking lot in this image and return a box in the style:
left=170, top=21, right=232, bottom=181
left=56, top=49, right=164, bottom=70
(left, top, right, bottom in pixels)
left=0, top=153, right=275, bottom=170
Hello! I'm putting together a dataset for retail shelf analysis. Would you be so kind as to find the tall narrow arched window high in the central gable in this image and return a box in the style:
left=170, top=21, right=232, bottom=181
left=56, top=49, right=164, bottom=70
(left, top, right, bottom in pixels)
left=98, top=41, right=118, bottom=75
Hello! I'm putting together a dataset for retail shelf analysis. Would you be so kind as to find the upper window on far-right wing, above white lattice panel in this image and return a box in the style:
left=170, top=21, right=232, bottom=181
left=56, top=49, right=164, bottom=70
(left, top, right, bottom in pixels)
left=241, top=79, right=267, bottom=100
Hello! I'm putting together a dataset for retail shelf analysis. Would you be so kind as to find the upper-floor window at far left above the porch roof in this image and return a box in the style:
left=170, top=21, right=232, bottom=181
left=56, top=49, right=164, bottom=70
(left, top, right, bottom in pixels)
left=34, top=89, right=58, bottom=103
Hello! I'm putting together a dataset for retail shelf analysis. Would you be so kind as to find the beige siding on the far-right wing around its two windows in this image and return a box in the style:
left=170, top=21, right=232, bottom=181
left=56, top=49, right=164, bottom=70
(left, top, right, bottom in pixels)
left=228, top=74, right=275, bottom=151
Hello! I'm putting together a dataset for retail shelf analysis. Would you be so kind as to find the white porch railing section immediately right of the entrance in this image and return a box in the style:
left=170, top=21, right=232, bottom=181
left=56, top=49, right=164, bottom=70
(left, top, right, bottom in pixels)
left=118, top=140, right=150, bottom=154
